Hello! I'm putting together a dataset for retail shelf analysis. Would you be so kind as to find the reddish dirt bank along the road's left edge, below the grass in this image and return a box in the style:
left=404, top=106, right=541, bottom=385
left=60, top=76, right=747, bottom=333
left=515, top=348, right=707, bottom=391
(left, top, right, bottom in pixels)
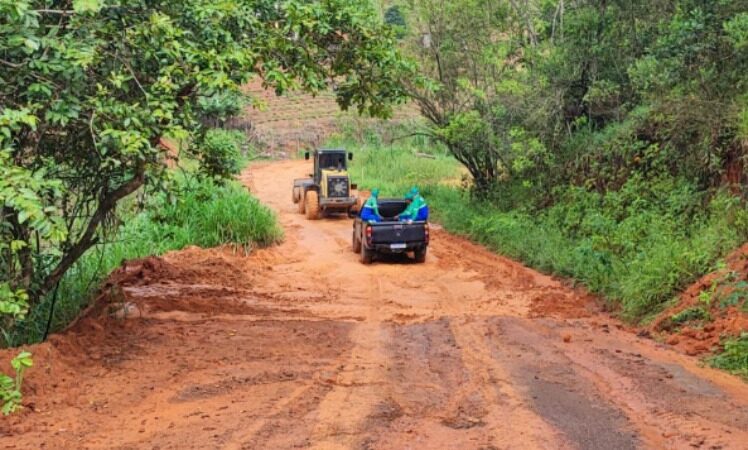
left=0, top=248, right=254, bottom=422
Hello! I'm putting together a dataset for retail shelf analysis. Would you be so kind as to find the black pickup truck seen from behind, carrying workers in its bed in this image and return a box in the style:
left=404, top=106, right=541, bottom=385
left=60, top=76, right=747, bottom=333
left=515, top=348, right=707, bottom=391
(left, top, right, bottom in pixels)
left=353, top=199, right=429, bottom=264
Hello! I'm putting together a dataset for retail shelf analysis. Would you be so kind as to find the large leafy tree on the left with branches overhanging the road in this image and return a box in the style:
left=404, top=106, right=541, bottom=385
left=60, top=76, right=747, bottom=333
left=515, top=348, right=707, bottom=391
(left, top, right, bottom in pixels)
left=0, top=0, right=404, bottom=324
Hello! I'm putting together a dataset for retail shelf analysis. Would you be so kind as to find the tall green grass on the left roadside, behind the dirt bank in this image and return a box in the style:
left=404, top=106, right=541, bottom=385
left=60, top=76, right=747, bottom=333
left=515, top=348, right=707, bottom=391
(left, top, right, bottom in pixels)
left=2, top=179, right=282, bottom=346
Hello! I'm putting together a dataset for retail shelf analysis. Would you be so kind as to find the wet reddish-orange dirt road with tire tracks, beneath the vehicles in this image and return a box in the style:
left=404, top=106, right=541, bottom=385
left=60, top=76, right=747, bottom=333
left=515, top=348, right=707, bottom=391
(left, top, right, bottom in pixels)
left=0, top=162, right=748, bottom=449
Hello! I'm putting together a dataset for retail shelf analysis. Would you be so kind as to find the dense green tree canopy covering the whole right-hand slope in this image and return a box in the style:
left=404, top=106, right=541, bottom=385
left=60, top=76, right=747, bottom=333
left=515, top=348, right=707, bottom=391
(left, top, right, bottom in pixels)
left=404, top=0, right=748, bottom=197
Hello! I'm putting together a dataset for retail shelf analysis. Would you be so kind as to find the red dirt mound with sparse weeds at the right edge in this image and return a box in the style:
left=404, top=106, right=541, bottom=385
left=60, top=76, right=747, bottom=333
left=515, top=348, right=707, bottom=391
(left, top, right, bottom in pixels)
left=644, top=243, right=748, bottom=356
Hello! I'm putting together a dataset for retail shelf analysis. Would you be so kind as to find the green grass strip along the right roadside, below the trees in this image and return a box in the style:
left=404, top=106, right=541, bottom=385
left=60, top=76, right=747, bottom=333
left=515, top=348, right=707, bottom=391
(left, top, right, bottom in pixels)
left=431, top=188, right=746, bottom=321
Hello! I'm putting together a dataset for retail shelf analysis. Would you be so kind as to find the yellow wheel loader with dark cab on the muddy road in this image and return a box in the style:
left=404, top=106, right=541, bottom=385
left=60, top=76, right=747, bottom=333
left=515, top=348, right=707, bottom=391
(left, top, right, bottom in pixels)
left=293, top=149, right=359, bottom=220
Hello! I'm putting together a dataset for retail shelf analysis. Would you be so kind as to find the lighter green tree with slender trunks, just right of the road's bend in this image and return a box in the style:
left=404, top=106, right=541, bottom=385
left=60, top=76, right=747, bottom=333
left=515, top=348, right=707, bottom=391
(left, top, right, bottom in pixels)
left=406, top=0, right=549, bottom=194
